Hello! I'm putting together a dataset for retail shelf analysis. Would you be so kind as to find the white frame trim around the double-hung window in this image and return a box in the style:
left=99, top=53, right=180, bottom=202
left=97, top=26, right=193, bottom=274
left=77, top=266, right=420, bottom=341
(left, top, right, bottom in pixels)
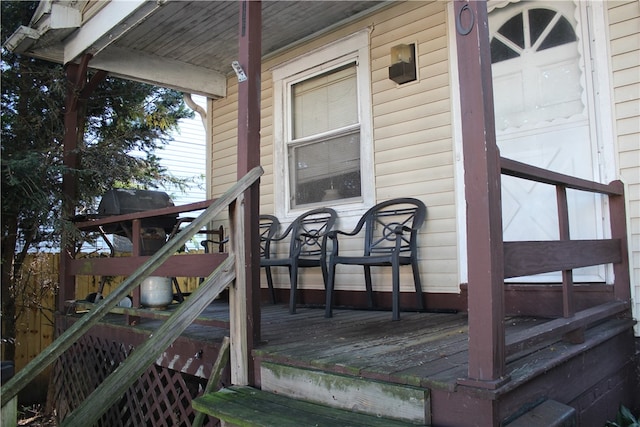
left=272, top=29, right=375, bottom=221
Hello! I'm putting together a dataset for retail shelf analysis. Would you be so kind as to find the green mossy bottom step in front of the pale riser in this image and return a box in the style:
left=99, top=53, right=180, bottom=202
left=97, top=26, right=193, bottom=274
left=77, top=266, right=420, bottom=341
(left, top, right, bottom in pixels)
left=192, top=386, right=422, bottom=427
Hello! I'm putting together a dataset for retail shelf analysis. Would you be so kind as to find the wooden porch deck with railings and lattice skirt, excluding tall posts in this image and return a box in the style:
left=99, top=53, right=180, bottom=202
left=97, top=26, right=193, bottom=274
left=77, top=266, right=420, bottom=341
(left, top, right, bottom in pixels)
left=3, top=146, right=636, bottom=426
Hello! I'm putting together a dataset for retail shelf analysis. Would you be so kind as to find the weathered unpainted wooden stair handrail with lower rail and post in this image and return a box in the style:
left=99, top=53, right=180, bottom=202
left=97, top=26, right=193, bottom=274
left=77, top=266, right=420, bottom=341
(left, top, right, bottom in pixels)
left=0, top=167, right=263, bottom=426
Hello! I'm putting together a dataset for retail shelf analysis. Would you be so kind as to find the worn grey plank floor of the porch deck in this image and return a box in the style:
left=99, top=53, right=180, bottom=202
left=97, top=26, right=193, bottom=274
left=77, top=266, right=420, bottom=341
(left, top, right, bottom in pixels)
left=254, top=306, right=629, bottom=395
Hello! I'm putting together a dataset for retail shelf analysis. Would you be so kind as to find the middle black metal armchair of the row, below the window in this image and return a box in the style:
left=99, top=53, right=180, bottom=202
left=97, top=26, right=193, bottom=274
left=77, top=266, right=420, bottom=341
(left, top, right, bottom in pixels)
left=260, top=208, right=338, bottom=314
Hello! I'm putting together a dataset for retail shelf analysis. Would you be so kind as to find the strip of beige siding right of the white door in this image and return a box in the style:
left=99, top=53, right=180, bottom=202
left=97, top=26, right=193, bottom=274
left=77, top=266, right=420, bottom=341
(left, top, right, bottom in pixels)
left=608, top=0, right=640, bottom=334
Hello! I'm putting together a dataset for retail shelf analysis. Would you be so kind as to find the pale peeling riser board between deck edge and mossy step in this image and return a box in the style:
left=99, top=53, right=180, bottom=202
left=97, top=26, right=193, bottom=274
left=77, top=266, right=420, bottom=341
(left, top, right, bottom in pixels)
left=260, top=361, right=431, bottom=425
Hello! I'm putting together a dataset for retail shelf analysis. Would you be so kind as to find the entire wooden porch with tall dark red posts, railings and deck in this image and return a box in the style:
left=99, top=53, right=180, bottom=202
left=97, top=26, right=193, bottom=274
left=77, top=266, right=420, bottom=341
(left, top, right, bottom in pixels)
left=3, top=2, right=636, bottom=426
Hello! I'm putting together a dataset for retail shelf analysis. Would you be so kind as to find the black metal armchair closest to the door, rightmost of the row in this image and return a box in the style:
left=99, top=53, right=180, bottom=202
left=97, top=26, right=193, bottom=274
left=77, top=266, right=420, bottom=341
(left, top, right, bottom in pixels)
left=325, top=198, right=427, bottom=320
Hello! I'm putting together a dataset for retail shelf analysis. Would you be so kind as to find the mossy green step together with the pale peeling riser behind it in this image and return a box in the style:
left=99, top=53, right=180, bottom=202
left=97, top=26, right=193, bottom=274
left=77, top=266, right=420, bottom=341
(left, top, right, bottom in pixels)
left=192, top=361, right=431, bottom=427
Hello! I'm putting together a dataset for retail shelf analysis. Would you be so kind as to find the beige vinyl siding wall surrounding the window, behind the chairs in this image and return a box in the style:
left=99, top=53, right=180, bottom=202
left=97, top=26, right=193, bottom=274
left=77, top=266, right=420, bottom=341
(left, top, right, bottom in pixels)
left=211, top=1, right=459, bottom=293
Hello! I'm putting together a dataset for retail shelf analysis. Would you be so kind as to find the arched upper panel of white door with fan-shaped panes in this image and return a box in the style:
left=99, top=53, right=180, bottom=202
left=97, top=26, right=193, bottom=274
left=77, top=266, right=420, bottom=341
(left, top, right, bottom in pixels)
left=491, top=4, right=584, bottom=131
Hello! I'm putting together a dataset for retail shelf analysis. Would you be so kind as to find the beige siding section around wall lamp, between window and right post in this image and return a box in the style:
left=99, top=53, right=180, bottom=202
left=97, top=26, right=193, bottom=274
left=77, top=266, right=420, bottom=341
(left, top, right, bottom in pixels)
left=370, top=2, right=459, bottom=292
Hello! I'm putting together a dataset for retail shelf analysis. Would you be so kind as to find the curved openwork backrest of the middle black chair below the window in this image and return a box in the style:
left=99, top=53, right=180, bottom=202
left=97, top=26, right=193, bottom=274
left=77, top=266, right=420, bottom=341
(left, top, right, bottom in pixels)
left=282, top=208, right=338, bottom=258
